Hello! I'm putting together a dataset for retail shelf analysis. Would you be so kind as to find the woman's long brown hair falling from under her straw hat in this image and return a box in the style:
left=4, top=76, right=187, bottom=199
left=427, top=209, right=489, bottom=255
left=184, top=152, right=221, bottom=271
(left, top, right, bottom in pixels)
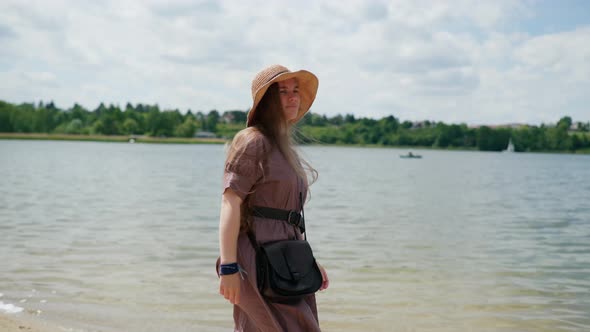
left=226, top=83, right=318, bottom=229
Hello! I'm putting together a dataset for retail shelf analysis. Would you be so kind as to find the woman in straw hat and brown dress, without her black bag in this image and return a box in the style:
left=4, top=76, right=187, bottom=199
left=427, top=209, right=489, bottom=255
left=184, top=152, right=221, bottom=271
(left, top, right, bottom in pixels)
left=218, top=65, right=329, bottom=332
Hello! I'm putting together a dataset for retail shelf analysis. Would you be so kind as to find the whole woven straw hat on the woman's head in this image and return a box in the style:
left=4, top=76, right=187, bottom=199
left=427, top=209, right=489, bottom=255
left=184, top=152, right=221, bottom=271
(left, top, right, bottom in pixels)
left=247, top=65, right=319, bottom=127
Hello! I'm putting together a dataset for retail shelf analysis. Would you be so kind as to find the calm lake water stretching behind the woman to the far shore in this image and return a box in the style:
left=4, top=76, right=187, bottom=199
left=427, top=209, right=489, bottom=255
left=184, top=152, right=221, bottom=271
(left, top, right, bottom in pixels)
left=0, top=141, right=590, bottom=331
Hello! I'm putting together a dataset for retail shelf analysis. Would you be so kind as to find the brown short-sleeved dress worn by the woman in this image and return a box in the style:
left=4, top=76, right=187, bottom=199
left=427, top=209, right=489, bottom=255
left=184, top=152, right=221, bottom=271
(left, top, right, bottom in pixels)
left=223, top=133, right=320, bottom=332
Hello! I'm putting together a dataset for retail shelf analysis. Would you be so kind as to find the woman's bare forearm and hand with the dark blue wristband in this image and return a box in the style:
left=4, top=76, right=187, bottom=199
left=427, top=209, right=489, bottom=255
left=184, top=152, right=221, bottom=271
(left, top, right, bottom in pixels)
left=219, top=188, right=242, bottom=304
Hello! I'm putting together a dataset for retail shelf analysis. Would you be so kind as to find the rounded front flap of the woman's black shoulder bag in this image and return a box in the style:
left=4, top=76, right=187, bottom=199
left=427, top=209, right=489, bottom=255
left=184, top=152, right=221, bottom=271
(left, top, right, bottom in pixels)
left=262, top=240, right=315, bottom=281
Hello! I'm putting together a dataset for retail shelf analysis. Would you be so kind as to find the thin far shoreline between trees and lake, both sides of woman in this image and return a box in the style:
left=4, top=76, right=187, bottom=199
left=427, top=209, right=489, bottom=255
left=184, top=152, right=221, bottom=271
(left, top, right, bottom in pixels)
left=0, top=133, right=590, bottom=155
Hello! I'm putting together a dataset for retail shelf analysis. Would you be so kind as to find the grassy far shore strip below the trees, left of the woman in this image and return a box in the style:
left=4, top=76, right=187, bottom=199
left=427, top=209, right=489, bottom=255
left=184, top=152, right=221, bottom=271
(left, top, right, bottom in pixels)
left=0, top=133, right=227, bottom=144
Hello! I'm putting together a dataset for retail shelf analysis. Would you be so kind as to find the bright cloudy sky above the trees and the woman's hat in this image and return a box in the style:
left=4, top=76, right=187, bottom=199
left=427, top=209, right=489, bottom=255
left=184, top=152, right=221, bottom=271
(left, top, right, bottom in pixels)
left=0, top=0, right=590, bottom=125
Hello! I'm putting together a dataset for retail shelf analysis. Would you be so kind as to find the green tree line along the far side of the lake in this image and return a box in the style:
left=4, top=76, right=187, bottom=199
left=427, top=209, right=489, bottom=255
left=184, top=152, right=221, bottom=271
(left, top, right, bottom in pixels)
left=0, top=101, right=590, bottom=152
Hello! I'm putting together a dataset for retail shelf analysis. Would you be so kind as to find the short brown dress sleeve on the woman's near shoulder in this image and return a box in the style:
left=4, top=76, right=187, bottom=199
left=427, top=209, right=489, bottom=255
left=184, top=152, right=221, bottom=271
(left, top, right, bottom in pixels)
left=223, top=135, right=268, bottom=200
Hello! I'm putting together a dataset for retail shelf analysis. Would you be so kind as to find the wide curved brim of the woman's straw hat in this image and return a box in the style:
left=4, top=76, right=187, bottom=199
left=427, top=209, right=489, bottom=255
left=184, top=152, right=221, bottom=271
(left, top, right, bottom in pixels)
left=246, top=70, right=319, bottom=127
